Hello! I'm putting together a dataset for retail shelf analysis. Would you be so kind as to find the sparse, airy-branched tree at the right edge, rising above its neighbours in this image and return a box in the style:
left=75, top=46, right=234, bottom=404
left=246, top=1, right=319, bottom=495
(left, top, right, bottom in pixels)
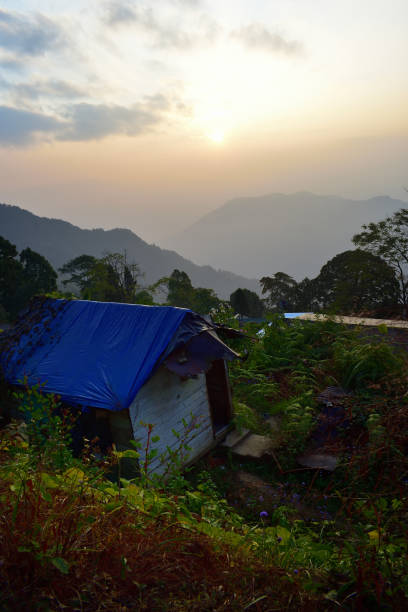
left=353, top=208, right=408, bottom=310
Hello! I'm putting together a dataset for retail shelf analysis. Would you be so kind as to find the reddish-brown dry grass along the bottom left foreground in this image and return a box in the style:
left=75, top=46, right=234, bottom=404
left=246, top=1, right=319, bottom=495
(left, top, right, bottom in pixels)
left=0, top=470, right=316, bottom=611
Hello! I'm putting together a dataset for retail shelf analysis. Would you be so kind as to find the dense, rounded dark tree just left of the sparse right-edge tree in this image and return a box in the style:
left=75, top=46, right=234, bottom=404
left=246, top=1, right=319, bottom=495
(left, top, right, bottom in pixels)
left=312, top=249, right=399, bottom=314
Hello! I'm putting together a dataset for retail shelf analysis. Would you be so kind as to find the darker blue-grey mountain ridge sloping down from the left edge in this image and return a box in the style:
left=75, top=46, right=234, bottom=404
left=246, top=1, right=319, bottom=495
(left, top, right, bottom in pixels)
left=0, top=204, right=259, bottom=299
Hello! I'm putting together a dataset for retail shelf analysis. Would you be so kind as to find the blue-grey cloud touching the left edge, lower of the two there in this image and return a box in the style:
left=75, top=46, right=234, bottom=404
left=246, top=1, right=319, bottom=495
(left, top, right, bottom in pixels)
left=0, top=106, right=61, bottom=146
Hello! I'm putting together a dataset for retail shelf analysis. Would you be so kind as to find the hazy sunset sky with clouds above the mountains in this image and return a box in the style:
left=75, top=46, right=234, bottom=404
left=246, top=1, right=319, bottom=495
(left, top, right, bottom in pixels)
left=0, top=0, right=408, bottom=241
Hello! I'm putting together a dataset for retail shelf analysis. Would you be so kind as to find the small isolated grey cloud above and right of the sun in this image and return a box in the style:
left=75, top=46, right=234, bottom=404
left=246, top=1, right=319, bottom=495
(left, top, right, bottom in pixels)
left=231, top=23, right=303, bottom=55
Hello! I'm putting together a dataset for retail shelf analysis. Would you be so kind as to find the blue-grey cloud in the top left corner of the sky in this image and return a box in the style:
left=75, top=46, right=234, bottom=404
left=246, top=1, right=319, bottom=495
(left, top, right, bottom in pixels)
left=0, top=9, right=64, bottom=55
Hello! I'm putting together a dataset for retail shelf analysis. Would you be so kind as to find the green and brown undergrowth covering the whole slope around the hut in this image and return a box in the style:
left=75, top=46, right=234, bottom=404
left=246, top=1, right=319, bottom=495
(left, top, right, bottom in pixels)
left=0, top=317, right=408, bottom=611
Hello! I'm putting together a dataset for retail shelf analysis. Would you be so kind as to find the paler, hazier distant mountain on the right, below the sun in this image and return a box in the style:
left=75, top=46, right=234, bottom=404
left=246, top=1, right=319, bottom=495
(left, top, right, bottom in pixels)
left=164, top=192, right=408, bottom=280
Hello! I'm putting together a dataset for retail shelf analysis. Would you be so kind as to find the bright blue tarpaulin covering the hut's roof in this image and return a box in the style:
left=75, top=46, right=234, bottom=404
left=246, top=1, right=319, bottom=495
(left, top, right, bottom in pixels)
left=0, top=299, right=191, bottom=410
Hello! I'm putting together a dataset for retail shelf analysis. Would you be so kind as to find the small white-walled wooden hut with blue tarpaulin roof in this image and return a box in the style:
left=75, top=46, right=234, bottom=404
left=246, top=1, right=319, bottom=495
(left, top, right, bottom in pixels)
left=0, top=298, right=238, bottom=473
